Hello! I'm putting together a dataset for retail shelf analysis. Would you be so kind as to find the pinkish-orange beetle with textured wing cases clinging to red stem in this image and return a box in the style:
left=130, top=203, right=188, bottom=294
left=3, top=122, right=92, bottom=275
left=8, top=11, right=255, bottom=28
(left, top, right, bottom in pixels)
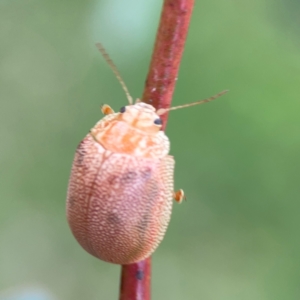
left=67, top=44, right=226, bottom=265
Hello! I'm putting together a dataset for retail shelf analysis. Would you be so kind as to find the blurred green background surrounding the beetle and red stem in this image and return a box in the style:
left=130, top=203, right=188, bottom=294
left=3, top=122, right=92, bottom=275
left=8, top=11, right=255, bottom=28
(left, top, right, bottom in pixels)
left=0, top=0, right=300, bottom=300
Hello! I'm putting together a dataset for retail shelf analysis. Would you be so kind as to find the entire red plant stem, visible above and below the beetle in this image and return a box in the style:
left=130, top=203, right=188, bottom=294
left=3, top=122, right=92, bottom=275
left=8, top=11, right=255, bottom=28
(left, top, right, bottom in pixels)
left=119, top=0, right=194, bottom=300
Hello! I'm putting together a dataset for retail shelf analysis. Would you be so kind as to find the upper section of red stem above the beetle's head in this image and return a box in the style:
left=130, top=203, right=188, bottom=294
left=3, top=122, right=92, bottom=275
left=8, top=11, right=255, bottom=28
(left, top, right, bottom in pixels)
left=142, top=0, right=194, bottom=129
